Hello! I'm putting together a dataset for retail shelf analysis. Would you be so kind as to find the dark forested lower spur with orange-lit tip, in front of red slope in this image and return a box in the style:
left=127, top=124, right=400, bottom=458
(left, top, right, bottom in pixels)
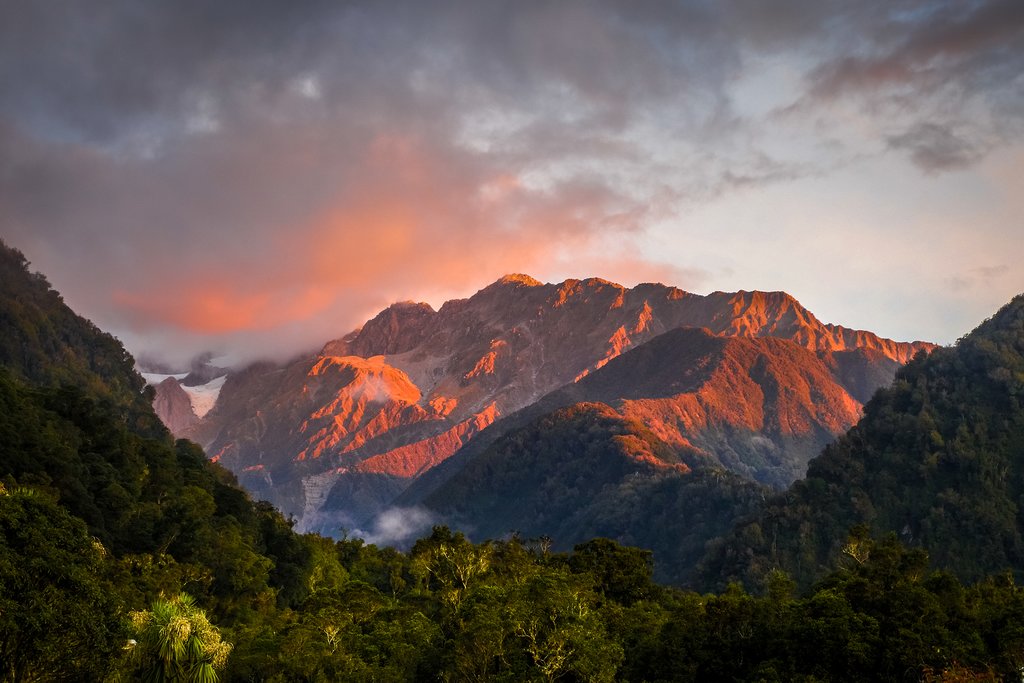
left=424, top=403, right=764, bottom=584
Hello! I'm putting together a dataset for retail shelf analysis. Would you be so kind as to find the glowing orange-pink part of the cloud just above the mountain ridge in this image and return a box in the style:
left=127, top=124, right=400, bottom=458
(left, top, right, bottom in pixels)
left=88, top=134, right=663, bottom=356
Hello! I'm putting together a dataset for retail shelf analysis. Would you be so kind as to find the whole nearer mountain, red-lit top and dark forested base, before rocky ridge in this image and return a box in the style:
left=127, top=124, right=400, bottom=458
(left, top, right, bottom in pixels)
left=407, top=328, right=872, bottom=585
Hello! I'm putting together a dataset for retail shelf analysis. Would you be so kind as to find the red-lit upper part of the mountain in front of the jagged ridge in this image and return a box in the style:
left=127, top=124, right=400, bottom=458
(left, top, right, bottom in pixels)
left=569, top=329, right=861, bottom=486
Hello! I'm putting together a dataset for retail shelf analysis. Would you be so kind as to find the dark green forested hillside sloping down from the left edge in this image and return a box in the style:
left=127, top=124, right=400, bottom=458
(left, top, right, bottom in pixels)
left=0, top=240, right=337, bottom=681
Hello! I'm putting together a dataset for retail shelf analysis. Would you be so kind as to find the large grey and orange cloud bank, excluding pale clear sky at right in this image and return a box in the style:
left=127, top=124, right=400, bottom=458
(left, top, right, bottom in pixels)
left=0, top=0, right=1024, bottom=362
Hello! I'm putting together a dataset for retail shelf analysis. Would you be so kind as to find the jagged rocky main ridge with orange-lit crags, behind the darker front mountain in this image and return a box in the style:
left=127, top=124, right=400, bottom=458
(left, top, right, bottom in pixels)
left=180, top=275, right=931, bottom=532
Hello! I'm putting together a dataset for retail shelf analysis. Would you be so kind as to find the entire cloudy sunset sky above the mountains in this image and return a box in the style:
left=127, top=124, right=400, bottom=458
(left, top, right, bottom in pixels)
left=0, top=0, right=1024, bottom=368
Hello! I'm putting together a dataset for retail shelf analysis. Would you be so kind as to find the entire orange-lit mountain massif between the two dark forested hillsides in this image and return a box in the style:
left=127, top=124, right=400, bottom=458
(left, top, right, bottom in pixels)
left=153, top=274, right=933, bottom=579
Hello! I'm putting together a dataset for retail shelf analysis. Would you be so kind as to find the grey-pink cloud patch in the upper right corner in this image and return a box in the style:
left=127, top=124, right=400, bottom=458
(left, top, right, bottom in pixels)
left=803, top=0, right=1024, bottom=167
